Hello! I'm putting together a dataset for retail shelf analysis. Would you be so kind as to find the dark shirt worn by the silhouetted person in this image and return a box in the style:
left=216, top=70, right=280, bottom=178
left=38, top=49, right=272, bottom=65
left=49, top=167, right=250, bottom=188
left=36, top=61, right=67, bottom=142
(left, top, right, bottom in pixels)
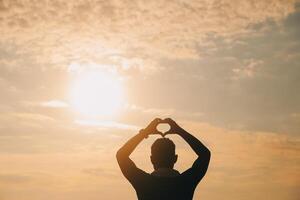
left=119, top=157, right=209, bottom=200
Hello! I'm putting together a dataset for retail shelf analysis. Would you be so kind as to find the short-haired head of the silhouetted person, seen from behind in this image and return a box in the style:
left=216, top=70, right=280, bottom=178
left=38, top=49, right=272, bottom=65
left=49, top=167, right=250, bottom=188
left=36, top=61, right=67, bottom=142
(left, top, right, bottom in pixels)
left=151, top=138, right=177, bottom=170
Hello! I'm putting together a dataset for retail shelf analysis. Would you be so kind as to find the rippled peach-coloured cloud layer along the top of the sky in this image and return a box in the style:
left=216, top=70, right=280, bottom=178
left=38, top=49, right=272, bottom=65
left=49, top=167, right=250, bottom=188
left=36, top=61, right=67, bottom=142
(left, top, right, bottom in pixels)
left=0, top=0, right=295, bottom=64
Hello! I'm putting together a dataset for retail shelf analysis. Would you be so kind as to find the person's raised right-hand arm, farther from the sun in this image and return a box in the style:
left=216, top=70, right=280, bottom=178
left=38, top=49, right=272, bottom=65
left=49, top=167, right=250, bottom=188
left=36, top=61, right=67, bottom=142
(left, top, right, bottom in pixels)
left=164, top=118, right=210, bottom=183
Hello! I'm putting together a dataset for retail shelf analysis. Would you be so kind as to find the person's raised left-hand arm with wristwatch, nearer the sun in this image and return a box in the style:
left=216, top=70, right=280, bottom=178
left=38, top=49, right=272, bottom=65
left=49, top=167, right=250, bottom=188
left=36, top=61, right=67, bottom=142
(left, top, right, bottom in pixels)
left=116, top=118, right=161, bottom=182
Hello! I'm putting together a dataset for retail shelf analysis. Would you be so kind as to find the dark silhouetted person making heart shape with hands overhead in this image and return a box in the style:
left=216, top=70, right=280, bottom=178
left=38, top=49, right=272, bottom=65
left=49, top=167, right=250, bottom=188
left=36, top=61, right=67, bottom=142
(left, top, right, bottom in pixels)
left=117, top=118, right=210, bottom=200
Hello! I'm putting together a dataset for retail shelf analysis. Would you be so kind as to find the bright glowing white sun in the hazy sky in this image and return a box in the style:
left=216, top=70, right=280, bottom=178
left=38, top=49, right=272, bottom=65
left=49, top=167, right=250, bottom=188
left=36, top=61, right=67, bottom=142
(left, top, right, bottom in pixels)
left=70, top=70, right=124, bottom=117
